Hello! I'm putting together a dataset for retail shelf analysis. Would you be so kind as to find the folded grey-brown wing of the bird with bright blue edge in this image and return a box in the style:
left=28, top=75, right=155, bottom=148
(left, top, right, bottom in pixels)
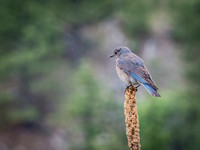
left=117, top=58, right=158, bottom=90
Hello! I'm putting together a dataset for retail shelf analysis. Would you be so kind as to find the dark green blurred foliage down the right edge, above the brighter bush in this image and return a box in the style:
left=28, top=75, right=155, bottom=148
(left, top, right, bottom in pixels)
left=171, top=0, right=200, bottom=94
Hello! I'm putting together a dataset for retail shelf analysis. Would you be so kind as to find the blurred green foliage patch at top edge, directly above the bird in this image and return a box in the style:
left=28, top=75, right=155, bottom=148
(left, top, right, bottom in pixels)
left=118, top=0, right=160, bottom=49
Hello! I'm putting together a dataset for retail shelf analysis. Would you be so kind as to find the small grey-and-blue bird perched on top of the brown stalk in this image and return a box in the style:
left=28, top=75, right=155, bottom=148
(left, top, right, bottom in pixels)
left=109, top=46, right=161, bottom=97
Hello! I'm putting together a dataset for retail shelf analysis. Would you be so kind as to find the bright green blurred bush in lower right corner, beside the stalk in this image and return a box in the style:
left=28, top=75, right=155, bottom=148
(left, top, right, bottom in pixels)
left=139, top=91, right=200, bottom=150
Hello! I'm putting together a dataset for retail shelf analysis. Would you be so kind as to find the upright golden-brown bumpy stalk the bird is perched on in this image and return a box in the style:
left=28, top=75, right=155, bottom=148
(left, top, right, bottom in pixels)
left=124, top=86, right=140, bottom=150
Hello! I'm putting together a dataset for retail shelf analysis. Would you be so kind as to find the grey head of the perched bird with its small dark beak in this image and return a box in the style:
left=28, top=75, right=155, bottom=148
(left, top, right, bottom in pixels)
left=109, top=46, right=131, bottom=58
